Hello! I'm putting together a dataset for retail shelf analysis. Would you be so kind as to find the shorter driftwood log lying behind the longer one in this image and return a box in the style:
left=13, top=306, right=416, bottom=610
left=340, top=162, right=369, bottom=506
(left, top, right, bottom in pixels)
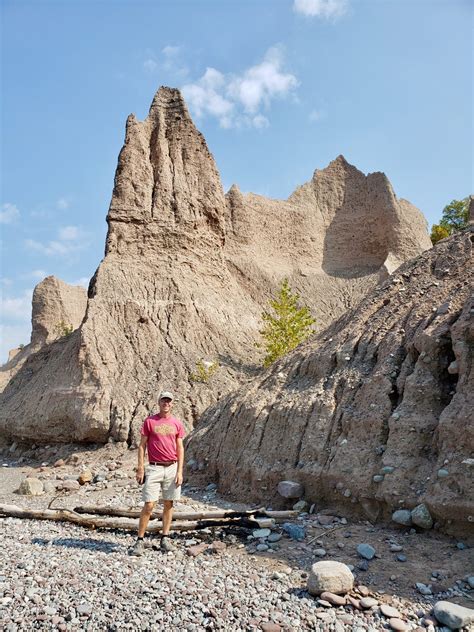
left=74, top=505, right=298, bottom=521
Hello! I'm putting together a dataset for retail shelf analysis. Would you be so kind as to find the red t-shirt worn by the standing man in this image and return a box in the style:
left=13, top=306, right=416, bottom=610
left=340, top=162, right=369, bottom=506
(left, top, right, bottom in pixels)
left=141, top=413, right=186, bottom=461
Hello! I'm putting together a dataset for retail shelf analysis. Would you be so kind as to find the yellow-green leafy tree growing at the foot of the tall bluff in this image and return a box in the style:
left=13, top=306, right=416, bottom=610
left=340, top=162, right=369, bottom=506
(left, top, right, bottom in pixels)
left=256, top=279, right=315, bottom=367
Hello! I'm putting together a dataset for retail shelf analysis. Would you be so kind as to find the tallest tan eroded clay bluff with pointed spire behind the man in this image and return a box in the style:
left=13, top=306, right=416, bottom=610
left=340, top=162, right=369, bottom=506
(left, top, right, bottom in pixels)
left=0, top=88, right=431, bottom=444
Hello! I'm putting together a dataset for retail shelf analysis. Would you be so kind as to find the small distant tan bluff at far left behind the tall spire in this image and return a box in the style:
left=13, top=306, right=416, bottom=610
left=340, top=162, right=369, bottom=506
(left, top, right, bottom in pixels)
left=0, top=276, right=87, bottom=391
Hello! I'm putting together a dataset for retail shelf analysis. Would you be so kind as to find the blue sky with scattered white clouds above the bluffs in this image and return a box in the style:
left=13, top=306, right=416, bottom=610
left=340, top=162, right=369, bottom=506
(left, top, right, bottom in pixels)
left=0, top=0, right=474, bottom=363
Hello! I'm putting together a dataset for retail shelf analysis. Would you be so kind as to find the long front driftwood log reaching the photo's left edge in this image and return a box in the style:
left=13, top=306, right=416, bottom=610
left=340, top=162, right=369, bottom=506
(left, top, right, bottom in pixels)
left=0, top=504, right=286, bottom=533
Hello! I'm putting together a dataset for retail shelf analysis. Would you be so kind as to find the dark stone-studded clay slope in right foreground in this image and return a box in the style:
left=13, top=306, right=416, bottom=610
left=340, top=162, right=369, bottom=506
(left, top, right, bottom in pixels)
left=187, top=224, right=474, bottom=533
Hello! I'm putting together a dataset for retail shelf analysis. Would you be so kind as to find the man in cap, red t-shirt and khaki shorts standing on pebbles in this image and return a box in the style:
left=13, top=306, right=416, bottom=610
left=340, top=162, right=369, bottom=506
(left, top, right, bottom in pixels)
left=130, top=391, right=185, bottom=555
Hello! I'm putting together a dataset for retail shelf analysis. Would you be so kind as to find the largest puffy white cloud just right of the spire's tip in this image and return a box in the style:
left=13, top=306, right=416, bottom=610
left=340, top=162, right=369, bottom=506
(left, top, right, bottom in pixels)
left=182, top=46, right=299, bottom=129
